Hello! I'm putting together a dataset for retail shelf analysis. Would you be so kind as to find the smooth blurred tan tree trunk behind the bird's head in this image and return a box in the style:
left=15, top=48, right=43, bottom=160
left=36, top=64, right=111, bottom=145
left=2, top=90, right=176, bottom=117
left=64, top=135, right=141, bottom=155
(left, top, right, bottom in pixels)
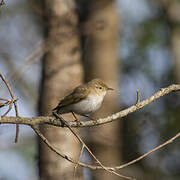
left=84, top=0, right=122, bottom=180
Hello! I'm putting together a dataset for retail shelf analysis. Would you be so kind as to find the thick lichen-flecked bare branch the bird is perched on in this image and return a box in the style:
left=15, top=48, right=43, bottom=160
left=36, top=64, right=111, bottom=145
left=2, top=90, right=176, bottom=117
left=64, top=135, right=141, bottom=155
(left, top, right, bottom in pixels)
left=0, top=84, right=180, bottom=127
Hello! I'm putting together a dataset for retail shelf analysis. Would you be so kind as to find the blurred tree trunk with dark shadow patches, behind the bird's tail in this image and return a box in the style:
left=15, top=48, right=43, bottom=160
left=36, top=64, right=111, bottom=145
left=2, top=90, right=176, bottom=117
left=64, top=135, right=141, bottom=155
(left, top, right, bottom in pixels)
left=39, top=0, right=82, bottom=180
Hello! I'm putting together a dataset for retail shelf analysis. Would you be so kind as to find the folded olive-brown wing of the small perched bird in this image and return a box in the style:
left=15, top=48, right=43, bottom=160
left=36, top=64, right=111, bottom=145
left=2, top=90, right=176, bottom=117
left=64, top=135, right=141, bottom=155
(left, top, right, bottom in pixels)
left=53, top=85, right=88, bottom=110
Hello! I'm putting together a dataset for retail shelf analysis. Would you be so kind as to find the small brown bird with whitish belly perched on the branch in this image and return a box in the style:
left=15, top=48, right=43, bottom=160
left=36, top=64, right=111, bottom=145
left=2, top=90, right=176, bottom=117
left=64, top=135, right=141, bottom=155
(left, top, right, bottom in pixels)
left=52, top=79, right=114, bottom=120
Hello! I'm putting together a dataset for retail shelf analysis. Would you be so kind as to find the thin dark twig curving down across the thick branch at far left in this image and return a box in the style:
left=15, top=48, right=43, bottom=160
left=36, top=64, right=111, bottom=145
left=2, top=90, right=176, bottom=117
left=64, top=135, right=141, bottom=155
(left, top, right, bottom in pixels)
left=0, top=73, right=19, bottom=143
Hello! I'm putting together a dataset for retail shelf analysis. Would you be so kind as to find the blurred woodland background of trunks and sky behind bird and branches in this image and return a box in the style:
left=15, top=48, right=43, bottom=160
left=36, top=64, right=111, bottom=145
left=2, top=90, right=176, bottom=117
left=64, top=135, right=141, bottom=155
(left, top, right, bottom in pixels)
left=0, top=0, right=180, bottom=180
